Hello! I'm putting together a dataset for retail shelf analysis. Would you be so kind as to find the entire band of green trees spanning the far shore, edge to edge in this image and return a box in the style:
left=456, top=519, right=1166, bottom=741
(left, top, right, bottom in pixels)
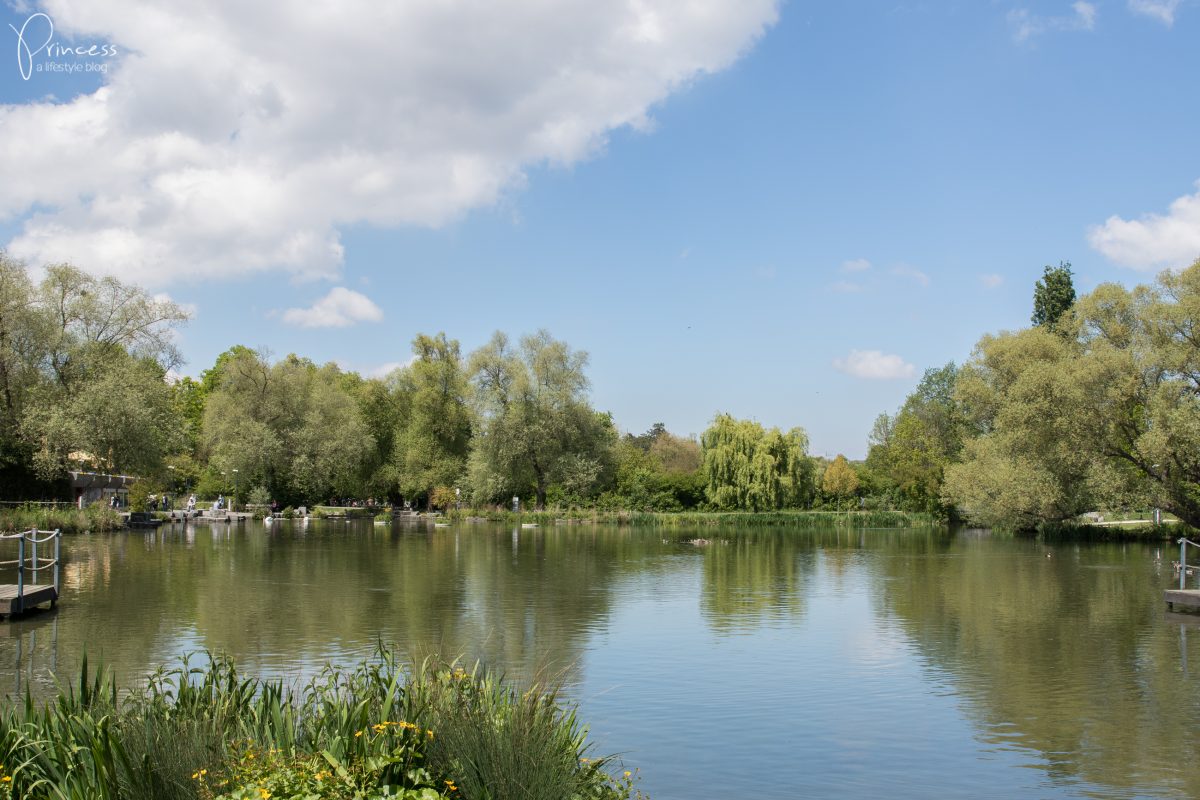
left=14, top=255, right=1180, bottom=529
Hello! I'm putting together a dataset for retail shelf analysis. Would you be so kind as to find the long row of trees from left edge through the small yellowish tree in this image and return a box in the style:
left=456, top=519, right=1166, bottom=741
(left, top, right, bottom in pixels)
left=0, top=255, right=857, bottom=511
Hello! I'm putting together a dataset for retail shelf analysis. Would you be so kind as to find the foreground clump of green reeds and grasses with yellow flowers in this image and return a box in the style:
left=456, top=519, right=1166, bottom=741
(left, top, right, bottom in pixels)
left=0, top=651, right=640, bottom=800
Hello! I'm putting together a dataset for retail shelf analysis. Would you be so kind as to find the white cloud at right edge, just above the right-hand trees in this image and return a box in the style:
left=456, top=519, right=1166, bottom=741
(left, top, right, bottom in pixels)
left=1087, top=181, right=1200, bottom=270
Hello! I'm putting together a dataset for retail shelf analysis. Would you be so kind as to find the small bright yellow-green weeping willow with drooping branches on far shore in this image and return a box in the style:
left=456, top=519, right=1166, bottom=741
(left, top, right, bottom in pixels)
left=700, top=414, right=812, bottom=511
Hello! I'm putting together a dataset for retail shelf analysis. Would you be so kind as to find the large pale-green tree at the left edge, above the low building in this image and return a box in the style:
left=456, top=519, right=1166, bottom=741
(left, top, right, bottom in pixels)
left=0, top=257, right=187, bottom=479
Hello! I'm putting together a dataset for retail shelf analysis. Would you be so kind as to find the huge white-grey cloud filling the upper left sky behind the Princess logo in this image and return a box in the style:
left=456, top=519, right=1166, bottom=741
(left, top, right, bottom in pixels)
left=0, top=0, right=780, bottom=287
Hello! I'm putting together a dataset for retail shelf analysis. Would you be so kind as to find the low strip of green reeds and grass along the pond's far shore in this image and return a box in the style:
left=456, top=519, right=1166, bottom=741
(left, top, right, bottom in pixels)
left=446, top=509, right=940, bottom=528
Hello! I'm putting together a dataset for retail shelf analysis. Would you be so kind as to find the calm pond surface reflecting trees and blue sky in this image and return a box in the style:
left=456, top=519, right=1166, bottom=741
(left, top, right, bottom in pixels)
left=0, top=522, right=1200, bottom=800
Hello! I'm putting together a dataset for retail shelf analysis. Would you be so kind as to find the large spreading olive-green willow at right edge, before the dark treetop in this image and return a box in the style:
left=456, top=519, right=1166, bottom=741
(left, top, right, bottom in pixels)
left=944, top=261, right=1200, bottom=527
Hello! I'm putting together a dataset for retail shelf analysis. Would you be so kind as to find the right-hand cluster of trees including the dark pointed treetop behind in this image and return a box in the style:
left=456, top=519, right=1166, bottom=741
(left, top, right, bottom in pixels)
left=863, top=260, right=1200, bottom=529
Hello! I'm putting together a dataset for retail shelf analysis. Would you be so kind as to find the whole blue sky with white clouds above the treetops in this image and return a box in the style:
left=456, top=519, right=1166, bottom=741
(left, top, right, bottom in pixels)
left=0, top=0, right=1200, bottom=457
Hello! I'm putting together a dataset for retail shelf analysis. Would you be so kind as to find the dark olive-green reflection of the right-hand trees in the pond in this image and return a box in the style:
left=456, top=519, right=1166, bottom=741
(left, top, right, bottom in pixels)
left=880, top=537, right=1200, bottom=796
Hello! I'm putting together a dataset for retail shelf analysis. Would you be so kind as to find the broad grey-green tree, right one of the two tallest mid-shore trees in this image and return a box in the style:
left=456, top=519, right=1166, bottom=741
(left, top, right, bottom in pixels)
left=468, top=330, right=616, bottom=509
